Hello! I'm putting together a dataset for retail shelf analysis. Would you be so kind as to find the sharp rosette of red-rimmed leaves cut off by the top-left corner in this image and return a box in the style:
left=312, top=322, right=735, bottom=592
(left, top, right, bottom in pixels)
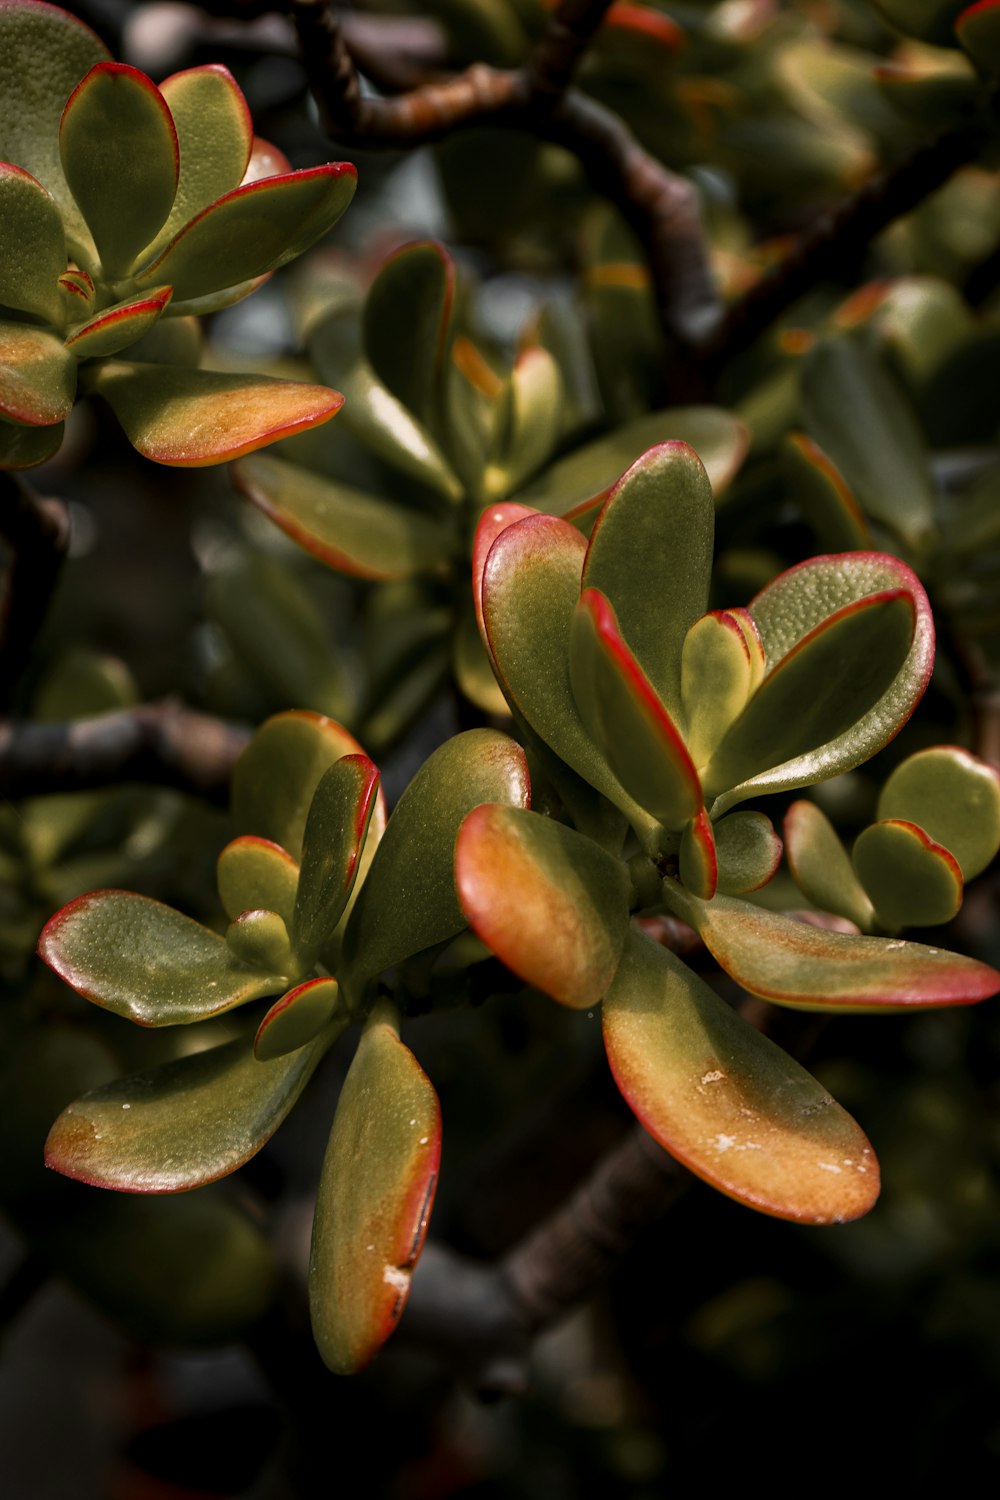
left=0, top=0, right=357, bottom=468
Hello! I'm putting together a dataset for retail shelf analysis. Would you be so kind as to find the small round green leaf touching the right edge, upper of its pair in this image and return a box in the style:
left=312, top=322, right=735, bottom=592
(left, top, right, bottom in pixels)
left=879, top=746, right=1000, bottom=881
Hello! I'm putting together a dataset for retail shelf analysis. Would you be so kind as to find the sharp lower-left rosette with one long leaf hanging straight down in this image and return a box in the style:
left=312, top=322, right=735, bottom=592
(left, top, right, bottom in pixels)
left=39, top=711, right=528, bottom=1373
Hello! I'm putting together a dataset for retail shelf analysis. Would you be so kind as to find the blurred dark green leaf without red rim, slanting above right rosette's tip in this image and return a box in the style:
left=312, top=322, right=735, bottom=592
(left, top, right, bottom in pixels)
left=802, top=338, right=936, bottom=546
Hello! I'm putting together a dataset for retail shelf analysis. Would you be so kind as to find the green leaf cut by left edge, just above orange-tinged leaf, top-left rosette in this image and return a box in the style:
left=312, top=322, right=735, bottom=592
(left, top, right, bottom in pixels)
left=0, top=164, right=66, bottom=323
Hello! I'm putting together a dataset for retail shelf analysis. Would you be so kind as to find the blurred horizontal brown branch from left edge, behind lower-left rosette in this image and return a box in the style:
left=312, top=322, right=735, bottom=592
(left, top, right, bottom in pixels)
left=0, top=699, right=250, bottom=803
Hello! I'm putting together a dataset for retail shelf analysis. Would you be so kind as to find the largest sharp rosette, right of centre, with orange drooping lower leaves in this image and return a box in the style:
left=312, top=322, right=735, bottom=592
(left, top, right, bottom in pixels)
left=456, top=444, right=1000, bottom=1223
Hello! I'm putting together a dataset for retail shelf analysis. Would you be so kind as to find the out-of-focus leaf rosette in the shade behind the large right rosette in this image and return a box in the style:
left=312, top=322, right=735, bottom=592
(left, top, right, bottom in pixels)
left=234, top=243, right=745, bottom=744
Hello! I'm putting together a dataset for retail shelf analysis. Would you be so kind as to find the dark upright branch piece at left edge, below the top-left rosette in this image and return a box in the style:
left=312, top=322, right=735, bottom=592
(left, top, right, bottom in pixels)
left=0, top=474, right=69, bottom=711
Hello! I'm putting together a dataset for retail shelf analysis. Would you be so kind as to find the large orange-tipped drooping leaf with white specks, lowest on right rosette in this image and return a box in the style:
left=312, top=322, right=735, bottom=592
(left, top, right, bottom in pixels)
left=604, top=932, right=879, bottom=1224
